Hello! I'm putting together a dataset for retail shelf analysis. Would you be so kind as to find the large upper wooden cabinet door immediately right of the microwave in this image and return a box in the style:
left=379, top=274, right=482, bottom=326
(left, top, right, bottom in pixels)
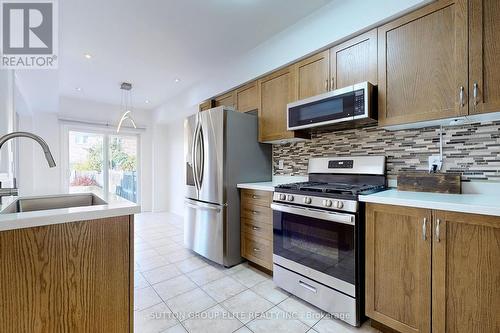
left=378, top=0, right=468, bottom=125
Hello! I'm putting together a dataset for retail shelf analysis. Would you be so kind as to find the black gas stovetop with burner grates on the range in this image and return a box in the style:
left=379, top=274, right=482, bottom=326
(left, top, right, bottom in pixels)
left=275, top=181, right=386, bottom=200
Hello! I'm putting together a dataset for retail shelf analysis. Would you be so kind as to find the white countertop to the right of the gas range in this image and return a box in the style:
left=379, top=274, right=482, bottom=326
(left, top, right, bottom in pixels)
left=359, top=189, right=500, bottom=216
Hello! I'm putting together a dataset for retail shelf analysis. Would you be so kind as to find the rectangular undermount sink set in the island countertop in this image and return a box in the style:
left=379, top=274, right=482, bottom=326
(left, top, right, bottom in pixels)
left=0, top=193, right=107, bottom=214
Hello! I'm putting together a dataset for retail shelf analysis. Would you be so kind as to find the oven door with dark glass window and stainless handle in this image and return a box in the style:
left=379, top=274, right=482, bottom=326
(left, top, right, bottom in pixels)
left=271, top=203, right=357, bottom=297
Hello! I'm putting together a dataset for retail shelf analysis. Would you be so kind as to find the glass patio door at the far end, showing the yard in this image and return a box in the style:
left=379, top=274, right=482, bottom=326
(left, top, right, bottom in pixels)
left=66, top=130, right=139, bottom=202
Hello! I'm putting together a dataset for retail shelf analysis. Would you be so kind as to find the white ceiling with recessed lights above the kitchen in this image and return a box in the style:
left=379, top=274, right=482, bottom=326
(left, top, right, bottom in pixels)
left=17, top=0, right=336, bottom=111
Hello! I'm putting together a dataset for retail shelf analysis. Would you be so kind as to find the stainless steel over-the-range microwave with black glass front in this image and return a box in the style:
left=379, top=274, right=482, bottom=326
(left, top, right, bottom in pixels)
left=287, top=82, right=377, bottom=130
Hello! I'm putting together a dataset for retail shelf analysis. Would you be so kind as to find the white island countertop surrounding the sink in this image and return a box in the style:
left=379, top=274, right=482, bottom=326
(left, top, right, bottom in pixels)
left=0, top=194, right=141, bottom=231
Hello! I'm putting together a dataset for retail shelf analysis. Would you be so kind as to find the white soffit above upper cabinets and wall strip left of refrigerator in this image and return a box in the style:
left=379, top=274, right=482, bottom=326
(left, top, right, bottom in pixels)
left=155, top=0, right=430, bottom=215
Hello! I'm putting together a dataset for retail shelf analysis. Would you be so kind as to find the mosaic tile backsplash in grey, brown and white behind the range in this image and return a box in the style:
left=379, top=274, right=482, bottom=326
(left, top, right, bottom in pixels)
left=273, top=121, right=500, bottom=181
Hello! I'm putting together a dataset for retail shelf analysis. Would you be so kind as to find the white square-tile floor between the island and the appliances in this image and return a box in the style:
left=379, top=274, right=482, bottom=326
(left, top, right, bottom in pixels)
left=134, top=213, right=377, bottom=333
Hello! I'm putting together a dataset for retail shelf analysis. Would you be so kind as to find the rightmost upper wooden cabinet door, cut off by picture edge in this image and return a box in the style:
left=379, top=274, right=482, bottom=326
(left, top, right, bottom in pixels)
left=469, top=0, right=500, bottom=114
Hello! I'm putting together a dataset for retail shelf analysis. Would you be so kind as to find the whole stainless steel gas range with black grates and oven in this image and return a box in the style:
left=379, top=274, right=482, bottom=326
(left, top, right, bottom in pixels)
left=271, top=156, right=386, bottom=326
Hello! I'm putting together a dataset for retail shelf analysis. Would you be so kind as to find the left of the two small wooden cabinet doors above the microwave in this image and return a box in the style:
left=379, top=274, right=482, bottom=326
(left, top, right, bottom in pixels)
left=295, top=51, right=330, bottom=99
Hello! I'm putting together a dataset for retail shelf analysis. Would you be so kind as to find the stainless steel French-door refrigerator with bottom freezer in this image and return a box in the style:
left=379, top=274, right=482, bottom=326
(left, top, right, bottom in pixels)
left=184, top=107, right=272, bottom=267
